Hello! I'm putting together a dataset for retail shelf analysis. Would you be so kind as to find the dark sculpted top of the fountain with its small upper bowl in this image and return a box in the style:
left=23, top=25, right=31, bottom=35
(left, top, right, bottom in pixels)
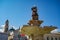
left=28, top=6, right=43, bottom=26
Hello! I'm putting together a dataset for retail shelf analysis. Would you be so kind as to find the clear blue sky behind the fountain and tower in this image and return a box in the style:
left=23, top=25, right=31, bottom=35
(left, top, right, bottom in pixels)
left=0, top=0, right=60, bottom=28
